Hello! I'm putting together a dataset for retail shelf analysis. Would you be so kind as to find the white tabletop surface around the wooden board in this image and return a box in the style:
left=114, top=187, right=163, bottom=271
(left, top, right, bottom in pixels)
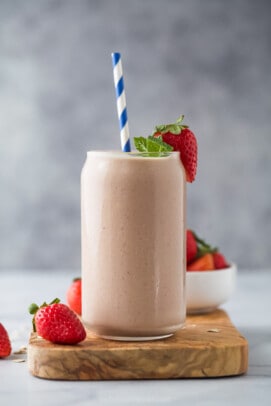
left=0, top=270, right=271, bottom=406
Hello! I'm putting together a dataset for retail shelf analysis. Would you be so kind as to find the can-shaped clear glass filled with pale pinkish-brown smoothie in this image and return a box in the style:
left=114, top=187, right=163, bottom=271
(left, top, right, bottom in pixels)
left=81, top=151, right=186, bottom=341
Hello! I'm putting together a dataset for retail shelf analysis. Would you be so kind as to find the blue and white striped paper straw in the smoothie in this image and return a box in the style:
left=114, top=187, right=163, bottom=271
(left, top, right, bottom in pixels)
left=112, top=52, right=131, bottom=152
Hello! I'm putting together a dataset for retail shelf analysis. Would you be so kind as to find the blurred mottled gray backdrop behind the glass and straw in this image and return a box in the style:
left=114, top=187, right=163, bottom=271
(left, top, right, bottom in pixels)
left=0, top=0, right=271, bottom=269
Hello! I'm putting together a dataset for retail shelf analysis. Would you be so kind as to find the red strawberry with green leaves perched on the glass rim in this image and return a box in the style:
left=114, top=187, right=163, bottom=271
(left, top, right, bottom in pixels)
left=153, top=116, right=198, bottom=182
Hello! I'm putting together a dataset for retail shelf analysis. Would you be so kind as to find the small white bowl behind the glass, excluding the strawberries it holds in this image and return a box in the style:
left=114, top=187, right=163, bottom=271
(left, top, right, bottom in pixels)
left=186, top=263, right=237, bottom=314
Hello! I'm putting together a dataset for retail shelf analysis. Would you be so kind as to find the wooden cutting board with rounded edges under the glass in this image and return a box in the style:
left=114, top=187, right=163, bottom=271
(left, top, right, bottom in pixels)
left=28, top=310, right=248, bottom=380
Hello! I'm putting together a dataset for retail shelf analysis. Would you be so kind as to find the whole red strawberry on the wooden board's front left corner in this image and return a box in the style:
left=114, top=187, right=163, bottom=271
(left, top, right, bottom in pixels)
left=29, top=299, right=86, bottom=344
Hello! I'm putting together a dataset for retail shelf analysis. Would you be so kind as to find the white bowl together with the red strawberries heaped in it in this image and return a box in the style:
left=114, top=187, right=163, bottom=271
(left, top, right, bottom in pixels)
left=186, top=230, right=237, bottom=314
